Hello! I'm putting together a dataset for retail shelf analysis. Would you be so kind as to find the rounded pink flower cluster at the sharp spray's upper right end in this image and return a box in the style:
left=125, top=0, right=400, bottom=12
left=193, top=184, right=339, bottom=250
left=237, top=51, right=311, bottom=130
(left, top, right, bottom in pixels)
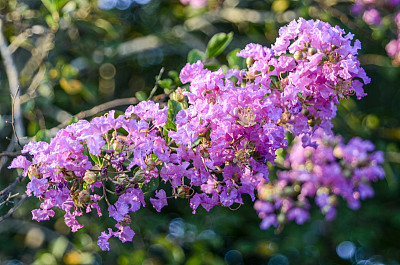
left=239, top=18, right=370, bottom=145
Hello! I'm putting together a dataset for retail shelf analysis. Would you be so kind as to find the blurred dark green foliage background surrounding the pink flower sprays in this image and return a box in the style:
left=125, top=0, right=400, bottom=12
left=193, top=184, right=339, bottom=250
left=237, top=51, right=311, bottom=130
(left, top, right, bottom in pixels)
left=0, top=0, right=400, bottom=265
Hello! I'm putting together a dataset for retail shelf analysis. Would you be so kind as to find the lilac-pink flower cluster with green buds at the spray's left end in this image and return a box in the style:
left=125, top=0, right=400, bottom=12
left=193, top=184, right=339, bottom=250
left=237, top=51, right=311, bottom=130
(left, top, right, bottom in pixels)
left=9, top=102, right=169, bottom=250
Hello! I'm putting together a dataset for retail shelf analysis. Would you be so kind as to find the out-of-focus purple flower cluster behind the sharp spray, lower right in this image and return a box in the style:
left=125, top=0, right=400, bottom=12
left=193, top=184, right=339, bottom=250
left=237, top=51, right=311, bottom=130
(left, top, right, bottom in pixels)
left=254, top=131, right=384, bottom=229
